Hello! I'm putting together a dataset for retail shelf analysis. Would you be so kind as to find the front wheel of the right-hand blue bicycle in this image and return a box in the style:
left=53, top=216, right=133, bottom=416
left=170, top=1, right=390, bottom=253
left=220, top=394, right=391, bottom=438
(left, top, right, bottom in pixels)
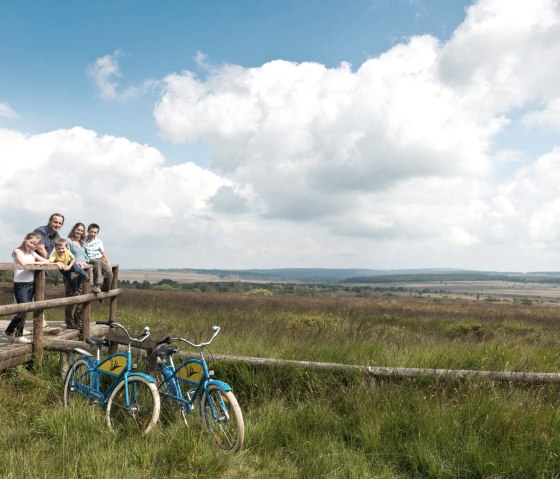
left=200, top=384, right=245, bottom=451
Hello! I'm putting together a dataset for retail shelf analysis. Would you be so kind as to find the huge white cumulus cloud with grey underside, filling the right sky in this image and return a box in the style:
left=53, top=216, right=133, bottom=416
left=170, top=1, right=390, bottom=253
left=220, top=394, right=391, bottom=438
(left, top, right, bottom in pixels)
left=150, top=0, right=560, bottom=270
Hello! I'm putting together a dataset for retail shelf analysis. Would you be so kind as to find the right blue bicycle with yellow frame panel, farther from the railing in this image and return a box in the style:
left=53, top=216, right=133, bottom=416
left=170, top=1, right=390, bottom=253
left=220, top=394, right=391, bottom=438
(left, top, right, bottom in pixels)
left=152, top=326, right=245, bottom=451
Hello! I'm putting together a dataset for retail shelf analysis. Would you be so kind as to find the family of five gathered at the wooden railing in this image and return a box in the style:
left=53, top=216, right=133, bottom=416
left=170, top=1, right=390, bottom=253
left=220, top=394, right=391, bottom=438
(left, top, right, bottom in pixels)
left=4, top=213, right=113, bottom=343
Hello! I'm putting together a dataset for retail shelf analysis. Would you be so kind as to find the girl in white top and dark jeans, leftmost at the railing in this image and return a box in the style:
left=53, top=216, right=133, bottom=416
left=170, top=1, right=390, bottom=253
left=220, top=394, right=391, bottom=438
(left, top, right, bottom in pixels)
left=4, top=233, right=64, bottom=343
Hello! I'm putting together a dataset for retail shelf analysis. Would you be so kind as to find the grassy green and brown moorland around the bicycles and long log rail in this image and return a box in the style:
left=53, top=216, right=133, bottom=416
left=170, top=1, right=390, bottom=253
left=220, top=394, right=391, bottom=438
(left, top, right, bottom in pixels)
left=0, top=285, right=560, bottom=478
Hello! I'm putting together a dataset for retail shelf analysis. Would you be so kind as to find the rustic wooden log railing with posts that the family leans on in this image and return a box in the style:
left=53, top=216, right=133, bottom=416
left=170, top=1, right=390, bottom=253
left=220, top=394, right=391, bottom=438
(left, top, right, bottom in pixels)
left=0, top=263, right=122, bottom=359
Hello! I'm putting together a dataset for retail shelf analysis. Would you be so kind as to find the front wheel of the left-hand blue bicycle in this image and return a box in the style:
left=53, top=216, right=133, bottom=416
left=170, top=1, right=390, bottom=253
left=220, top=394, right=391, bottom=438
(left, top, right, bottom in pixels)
left=107, top=376, right=160, bottom=434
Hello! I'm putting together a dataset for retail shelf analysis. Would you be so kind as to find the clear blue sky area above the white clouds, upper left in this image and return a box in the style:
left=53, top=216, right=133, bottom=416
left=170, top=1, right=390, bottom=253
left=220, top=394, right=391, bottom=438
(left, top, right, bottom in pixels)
left=0, top=0, right=469, bottom=162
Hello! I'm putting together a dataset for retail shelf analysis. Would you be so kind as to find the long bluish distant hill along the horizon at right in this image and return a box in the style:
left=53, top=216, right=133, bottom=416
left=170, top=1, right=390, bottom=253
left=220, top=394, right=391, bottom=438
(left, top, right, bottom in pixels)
left=157, top=268, right=560, bottom=283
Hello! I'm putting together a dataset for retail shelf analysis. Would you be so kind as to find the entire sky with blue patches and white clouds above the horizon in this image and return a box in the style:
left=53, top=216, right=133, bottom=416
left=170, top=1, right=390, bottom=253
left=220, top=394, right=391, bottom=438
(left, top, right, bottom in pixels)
left=0, top=0, right=560, bottom=271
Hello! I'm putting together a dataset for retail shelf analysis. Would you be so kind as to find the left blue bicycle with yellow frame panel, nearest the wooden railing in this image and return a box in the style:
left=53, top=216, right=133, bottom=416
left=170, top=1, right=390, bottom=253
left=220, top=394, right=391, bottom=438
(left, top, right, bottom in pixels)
left=64, top=321, right=160, bottom=434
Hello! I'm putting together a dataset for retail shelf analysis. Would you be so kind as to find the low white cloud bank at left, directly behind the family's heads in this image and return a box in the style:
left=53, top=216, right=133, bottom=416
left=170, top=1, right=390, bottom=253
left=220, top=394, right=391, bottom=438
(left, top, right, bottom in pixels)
left=0, top=128, right=229, bottom=262
